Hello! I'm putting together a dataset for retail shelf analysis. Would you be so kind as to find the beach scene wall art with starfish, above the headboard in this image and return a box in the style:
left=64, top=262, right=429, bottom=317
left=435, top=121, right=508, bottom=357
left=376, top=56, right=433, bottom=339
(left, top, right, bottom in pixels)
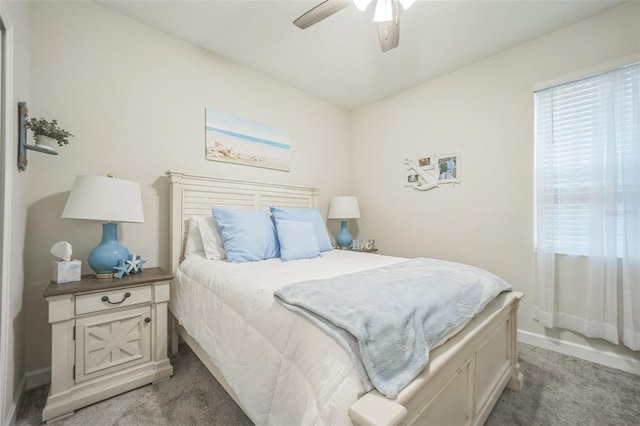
left=205, top=108, right=291, bottom=172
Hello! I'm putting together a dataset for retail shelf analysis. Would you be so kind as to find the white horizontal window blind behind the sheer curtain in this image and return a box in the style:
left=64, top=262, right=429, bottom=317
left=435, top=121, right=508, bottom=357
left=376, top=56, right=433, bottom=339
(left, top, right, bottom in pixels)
left=534, top=64, right=640, bottom=255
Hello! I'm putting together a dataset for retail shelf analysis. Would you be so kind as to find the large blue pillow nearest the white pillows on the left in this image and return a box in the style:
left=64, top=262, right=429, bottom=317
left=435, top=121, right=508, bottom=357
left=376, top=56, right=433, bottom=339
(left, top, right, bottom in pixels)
left=211, top=207, right=280, bottom=263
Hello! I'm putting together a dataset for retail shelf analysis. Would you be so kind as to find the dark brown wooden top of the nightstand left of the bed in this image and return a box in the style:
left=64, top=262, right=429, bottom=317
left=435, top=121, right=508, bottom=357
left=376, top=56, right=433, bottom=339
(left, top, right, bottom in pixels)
left=43, top=268, right=173, bottom=297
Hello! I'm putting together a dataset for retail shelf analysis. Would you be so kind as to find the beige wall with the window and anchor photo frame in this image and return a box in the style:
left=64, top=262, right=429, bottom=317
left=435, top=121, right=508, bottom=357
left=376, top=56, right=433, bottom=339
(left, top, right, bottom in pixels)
left=352, top=2, right=640, bottom=359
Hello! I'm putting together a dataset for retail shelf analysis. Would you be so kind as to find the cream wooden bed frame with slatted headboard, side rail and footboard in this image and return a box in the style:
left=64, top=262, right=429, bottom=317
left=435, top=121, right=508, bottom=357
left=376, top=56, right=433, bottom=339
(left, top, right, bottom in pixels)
left=167, top=170, right=523, bottom=425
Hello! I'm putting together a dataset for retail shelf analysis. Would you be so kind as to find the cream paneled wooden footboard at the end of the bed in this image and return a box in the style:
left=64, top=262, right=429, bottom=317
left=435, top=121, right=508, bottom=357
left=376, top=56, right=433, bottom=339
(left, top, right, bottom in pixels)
left=349, top=292, right=523, bottom=425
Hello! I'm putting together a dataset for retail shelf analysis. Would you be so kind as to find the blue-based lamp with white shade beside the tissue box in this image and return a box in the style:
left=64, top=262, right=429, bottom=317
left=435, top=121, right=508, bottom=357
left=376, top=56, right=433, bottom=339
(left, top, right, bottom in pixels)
left=62, top=175, right=144, bottom=278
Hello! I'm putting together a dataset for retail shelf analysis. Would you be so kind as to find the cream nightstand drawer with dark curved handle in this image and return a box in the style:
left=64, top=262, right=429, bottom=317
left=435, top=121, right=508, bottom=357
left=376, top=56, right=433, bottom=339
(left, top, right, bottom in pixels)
left=76, top=285, right=151, bottom=315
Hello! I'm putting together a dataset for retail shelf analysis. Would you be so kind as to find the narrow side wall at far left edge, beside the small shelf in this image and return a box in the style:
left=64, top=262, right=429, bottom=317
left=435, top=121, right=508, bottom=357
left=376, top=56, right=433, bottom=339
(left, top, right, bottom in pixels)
left=0, top=2, right=30, bottom=424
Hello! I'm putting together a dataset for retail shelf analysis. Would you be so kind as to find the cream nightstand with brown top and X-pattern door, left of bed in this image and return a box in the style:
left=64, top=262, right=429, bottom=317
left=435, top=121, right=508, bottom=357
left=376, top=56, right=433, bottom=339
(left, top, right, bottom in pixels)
left=42, top=268, right=173, bottom=421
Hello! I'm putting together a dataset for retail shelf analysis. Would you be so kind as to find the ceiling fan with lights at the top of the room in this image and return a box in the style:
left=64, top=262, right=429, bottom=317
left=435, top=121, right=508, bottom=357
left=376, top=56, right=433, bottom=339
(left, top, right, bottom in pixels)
left=293, top=0, right=414, bottom=52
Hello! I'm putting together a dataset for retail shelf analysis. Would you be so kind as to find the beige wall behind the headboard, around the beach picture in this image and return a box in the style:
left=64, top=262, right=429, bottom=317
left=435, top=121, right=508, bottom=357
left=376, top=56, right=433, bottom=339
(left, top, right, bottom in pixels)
left=25, top=2, right=349, bottom=371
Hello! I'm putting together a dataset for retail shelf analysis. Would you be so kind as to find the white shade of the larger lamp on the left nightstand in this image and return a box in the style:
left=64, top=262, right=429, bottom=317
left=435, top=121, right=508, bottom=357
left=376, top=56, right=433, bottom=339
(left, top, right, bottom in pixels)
left=62, top=176, right=144, bottom=223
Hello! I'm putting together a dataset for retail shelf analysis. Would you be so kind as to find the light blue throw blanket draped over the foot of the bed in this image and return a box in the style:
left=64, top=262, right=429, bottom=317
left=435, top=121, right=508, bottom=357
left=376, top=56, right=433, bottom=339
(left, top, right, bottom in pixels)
left=274, top=258, right=511, bottom=398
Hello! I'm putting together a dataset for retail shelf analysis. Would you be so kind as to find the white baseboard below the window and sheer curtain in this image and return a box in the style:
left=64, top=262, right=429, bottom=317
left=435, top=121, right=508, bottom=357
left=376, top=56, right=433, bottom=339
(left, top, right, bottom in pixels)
left=518, top=330, right=640, bottom=376
